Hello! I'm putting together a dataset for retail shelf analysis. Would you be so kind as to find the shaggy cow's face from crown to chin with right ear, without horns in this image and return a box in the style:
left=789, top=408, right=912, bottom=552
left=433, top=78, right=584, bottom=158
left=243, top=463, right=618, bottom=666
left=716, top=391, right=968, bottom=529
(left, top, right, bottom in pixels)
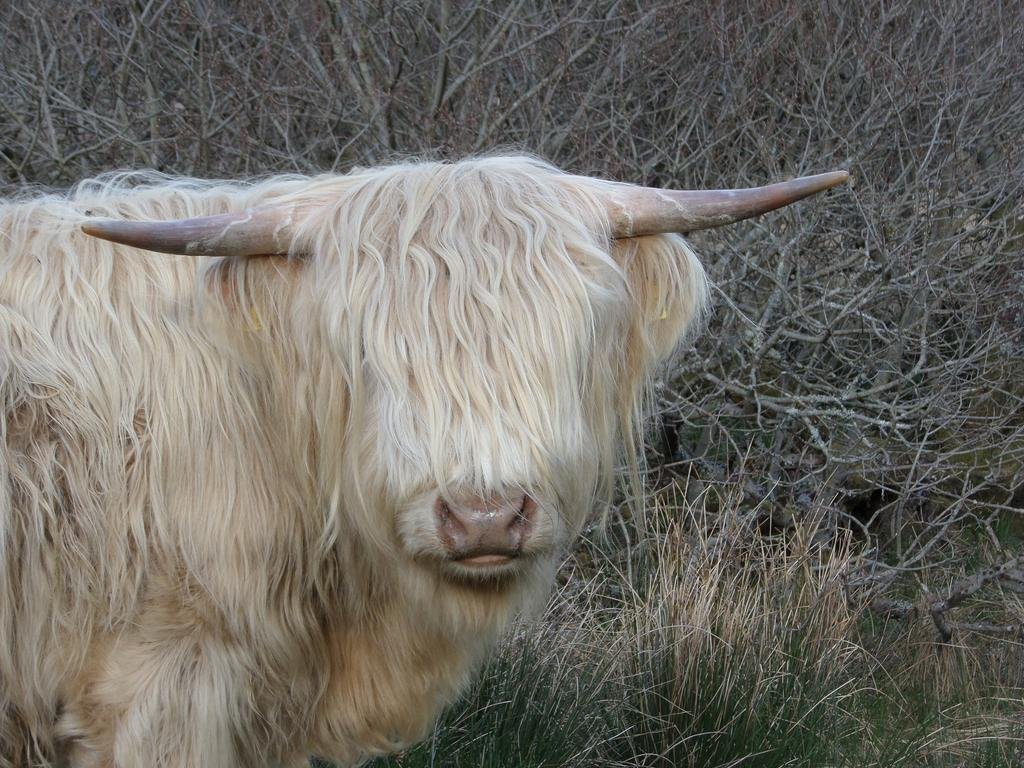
left=299, top=159, right=705, bottom=583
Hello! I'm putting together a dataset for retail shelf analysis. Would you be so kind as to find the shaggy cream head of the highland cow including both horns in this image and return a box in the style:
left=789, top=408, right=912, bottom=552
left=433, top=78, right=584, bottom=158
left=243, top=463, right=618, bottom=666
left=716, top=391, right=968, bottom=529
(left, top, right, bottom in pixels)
left=82, top=158, right=831, bottom=583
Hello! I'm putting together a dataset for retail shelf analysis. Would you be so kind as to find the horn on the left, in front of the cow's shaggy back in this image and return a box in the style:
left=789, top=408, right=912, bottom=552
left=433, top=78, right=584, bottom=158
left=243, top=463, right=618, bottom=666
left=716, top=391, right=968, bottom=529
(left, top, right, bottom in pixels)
left=82, top=208, right=295, bottom=256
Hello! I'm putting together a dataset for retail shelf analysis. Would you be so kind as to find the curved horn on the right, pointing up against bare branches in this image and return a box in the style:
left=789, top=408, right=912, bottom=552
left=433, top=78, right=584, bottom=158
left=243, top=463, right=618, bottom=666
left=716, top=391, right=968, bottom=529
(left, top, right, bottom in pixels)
left=607, top=171, right=850, bottom=238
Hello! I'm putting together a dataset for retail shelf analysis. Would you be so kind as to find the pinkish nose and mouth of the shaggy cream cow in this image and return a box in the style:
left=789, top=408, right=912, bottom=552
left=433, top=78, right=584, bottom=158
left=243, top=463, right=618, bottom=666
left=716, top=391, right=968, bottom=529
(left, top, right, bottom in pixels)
left=434, top=494, right=537, bottom=565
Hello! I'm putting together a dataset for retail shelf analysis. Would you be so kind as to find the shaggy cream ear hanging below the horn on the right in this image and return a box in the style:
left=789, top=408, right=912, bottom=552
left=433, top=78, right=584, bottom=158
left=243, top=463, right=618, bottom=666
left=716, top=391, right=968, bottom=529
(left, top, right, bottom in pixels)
left=615, top=234, right=708, bottom=370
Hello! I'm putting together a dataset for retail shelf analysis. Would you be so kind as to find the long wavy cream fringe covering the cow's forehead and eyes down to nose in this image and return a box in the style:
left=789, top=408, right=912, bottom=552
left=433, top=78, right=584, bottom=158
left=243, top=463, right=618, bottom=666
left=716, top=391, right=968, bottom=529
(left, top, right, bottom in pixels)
left=296, top=165, right=629, bottom=495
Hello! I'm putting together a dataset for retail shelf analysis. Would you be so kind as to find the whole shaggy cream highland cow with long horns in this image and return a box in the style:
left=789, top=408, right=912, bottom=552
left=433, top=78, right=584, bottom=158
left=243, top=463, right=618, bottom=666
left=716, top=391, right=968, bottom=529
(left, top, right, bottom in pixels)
left=0, top=157, right=846, bottom=768
